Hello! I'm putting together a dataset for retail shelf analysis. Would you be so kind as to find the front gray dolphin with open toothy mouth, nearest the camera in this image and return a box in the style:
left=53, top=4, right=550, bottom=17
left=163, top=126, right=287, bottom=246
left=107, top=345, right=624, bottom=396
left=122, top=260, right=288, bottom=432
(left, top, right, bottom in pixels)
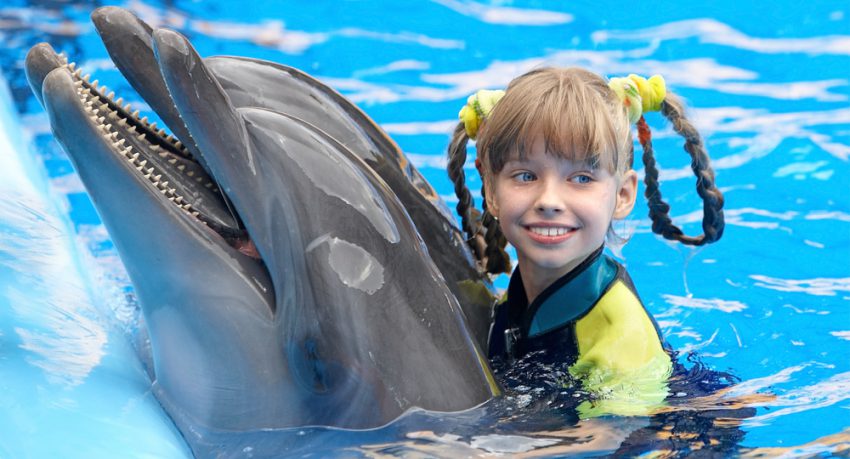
left=27, top=6, right=498, bottom=452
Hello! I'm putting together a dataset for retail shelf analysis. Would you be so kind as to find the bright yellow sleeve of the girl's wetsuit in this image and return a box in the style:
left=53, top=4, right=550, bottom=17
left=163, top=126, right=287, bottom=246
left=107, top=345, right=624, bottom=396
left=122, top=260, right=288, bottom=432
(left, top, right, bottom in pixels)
left=570, top=280, right=672, bottom=417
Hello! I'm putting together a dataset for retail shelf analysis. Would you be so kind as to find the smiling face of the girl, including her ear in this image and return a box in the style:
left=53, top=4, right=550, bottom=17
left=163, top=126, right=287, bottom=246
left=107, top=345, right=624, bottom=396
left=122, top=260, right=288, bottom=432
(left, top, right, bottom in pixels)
left=487, top=137, right=637, bottom=284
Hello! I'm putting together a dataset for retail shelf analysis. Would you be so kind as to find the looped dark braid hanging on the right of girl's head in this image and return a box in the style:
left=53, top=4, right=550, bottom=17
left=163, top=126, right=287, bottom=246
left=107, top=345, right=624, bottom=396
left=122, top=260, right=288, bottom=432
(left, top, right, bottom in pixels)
left=637, top=95, right=725, bottom=246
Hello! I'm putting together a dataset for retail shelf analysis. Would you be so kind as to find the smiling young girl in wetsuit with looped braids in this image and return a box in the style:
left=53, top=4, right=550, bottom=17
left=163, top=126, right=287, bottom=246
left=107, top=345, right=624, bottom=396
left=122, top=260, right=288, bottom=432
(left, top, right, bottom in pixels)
left=449, top=68, right=723, bottom=415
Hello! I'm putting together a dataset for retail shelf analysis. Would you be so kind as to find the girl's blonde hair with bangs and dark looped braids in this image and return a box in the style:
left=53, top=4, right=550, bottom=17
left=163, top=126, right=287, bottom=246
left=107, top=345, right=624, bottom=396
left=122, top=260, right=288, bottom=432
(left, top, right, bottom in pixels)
left=448, top=67, right=724, bottom=274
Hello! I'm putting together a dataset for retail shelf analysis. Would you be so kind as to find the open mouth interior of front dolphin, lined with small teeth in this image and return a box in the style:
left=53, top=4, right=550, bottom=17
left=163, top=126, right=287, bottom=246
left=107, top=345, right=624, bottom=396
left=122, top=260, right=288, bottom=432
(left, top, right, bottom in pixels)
left=34, top=50, right=259, bottom=258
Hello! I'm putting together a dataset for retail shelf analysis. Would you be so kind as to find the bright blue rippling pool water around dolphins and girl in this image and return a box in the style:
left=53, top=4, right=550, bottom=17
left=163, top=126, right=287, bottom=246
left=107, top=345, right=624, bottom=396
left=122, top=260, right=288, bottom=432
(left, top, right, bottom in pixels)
left=0, top=0, right=850, bottom=457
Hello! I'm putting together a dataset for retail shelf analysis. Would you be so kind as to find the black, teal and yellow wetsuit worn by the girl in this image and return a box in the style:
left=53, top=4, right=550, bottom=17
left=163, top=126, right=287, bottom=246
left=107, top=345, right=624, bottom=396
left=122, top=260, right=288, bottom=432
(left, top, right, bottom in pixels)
left=488, top=247, right=672, bottom=414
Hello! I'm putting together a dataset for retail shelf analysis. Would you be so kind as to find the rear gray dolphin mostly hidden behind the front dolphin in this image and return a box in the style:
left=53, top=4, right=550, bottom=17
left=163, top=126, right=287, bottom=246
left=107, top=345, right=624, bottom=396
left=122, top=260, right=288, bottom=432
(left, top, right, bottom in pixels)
left=92, top=7, right=495, bottom=347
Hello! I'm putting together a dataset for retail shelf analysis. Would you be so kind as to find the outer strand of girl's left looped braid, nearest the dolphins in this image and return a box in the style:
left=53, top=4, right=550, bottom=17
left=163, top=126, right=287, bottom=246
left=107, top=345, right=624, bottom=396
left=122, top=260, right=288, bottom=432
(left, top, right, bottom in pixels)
left=448, top=123, right=486, bottom=261
